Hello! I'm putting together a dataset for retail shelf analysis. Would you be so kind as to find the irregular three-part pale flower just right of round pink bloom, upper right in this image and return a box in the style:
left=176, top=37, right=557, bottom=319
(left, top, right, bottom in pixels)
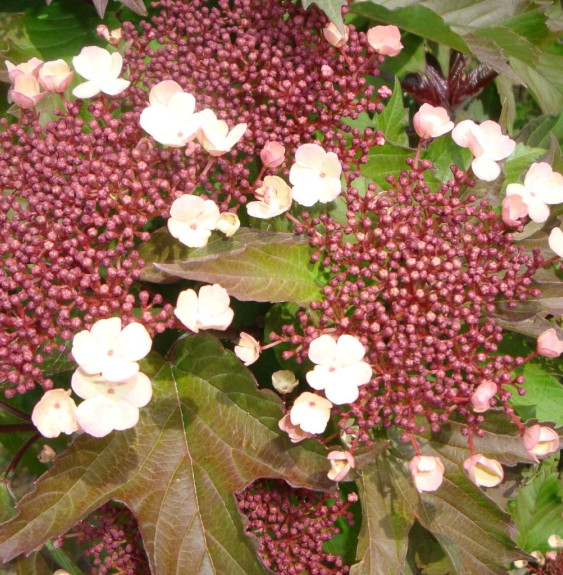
left=452, top=120, right=516, bottom=182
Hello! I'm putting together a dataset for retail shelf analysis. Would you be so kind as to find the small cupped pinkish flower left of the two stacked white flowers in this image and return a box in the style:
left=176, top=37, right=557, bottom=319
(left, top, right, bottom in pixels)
left=31, top=389, right=80, bottom=437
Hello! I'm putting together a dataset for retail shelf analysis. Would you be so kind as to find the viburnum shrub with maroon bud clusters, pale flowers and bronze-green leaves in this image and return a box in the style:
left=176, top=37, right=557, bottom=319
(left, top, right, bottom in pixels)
left=0, top=0, right=563, bottom=575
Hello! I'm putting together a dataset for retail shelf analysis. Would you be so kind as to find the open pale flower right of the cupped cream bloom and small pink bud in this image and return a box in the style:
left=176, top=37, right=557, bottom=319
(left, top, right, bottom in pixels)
left=289, top=144, right=342, bottom=206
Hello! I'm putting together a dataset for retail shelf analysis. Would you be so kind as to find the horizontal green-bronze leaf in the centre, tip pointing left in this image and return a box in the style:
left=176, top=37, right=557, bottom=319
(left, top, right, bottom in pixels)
left=153, top=229, right=321, bottom=305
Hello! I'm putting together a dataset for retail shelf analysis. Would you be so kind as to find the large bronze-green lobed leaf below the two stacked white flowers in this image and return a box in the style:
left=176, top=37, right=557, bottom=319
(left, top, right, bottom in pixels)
left=0, top=336, right=331, bottom=575
